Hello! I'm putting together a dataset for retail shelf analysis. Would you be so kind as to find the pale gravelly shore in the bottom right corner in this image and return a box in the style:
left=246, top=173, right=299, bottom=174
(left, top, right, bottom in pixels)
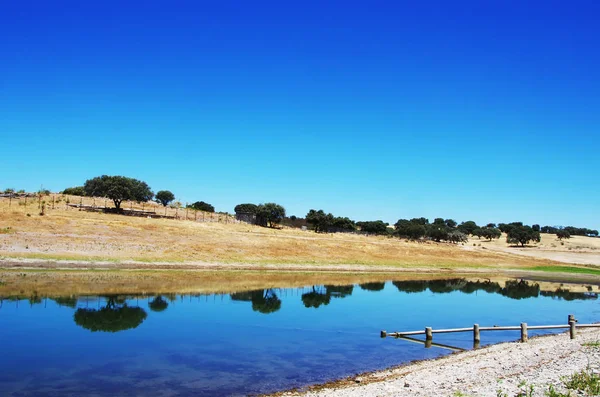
left=277, top=328, right=600, bottom=397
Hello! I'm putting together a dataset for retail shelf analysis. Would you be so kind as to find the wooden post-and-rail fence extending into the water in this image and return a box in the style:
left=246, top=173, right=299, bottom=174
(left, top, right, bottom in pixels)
left=381, top=314, right=600, bottom=349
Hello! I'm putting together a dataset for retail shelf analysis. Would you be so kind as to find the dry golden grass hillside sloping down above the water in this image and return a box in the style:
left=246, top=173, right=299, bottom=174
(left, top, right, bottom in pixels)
left=0, top=196, right=600, bottom=268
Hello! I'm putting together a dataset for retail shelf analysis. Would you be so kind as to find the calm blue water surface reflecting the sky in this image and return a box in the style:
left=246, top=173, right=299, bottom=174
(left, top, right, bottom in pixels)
left=0, top=283, right=600, bottom=396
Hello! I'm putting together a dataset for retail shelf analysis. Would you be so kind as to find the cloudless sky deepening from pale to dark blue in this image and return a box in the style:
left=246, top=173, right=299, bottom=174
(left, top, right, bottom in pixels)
left=0, top=0, right=600, bottom=228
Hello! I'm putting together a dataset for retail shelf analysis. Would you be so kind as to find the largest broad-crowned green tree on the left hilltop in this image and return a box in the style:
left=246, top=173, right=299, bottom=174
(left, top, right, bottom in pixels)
left=83, top=175, right=154, bottom=210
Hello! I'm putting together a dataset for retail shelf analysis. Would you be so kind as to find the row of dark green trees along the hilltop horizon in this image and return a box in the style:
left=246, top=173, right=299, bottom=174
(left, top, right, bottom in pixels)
left=54, top=175, right=598, bottom=246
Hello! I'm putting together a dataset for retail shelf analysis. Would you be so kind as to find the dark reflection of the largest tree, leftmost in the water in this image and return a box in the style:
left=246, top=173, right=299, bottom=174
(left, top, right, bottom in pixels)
left=74, top=296, right=147, bottom=332
